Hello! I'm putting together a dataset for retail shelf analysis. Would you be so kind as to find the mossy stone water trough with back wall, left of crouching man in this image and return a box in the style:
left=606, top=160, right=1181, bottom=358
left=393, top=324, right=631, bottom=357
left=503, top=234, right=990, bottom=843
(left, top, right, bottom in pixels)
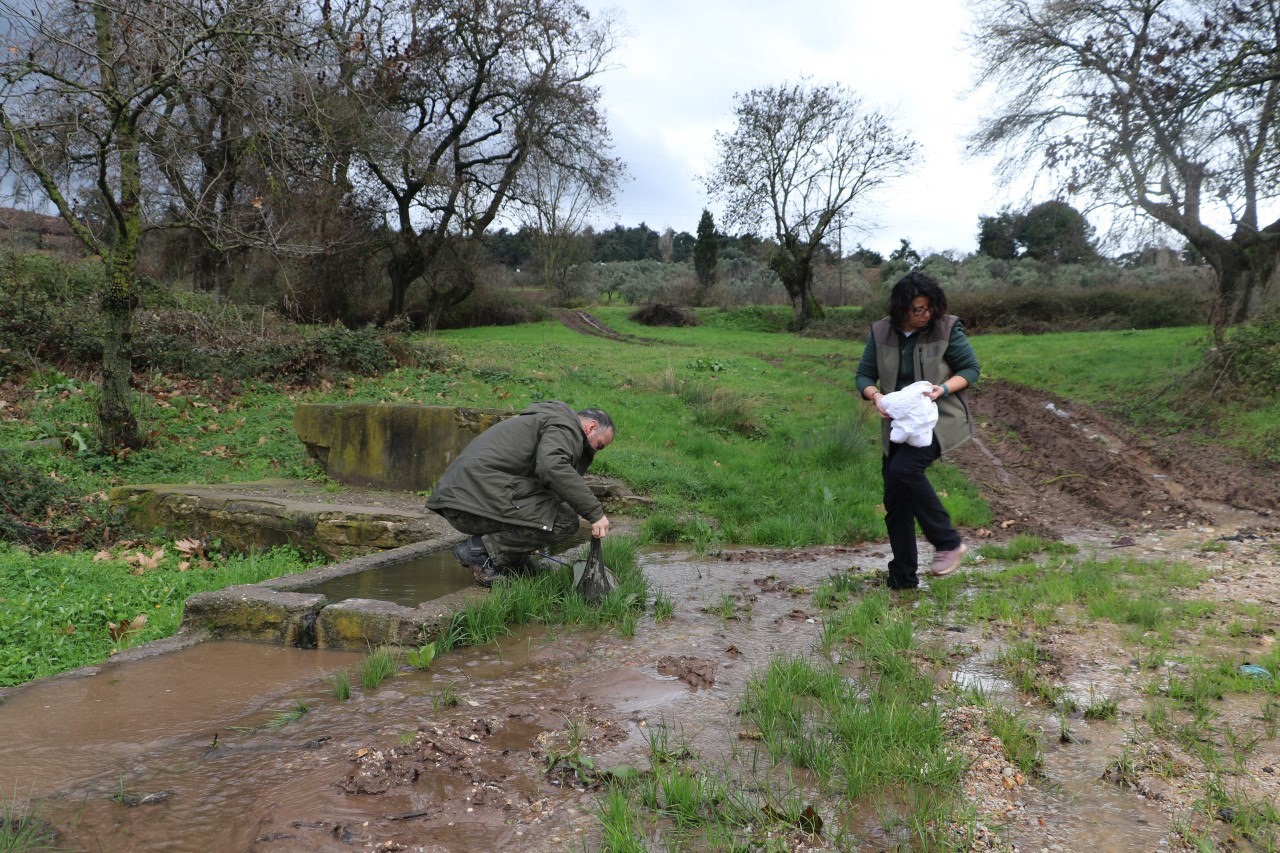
left=110, top=405, right=644, bottom=649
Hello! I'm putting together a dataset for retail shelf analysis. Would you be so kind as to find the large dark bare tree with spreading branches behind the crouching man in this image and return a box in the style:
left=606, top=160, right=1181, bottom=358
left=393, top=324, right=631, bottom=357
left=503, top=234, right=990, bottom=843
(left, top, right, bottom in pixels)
left=312, top=0, right=614, bottom=323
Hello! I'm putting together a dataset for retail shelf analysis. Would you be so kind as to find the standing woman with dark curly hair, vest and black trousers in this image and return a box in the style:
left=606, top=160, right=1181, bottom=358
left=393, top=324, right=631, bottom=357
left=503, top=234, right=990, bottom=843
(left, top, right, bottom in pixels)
left=858, top=272, right=978, bottom=589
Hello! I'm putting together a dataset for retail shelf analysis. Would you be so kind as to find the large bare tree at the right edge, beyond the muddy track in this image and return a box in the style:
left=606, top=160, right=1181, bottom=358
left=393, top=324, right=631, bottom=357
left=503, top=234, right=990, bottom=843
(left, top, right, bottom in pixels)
left=972, top=0, right=1280, bottom=332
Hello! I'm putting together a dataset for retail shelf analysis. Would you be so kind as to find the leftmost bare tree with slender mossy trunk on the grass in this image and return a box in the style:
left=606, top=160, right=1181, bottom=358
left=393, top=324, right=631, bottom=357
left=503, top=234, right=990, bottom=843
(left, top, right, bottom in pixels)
left=0, top=0, right=298, bottom=447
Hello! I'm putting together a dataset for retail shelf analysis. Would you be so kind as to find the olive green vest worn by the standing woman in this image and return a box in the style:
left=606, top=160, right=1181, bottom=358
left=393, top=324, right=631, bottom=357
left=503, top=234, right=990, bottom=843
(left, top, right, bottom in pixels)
left=872, top=314, right=973, bottom=453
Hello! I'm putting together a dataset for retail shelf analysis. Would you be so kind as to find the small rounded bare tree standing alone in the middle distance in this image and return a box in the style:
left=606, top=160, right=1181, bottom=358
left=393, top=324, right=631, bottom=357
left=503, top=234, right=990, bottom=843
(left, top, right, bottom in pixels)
left=705, top=82, right=918, bottom=328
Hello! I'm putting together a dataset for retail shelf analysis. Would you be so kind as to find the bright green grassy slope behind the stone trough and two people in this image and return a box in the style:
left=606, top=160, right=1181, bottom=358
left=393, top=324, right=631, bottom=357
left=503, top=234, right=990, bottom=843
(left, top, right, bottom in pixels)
left=0, top=315, right=1274, bottom=684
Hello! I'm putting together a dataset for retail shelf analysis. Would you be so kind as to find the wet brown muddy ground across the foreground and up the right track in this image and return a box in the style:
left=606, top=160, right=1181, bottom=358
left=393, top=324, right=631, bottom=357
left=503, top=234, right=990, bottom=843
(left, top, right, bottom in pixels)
left=10, top=383, right=1280, bottom=850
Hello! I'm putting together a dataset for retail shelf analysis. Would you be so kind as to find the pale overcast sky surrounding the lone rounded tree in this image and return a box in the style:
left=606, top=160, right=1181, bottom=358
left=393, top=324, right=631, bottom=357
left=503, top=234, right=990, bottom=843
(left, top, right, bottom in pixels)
left=580, top=0, right=1013, bottom=255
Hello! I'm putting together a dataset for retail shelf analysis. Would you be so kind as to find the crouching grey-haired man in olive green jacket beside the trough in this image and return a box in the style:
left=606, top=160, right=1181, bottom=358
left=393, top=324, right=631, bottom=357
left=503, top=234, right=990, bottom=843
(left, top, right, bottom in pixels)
left=426, top=401, right=613, bottom=587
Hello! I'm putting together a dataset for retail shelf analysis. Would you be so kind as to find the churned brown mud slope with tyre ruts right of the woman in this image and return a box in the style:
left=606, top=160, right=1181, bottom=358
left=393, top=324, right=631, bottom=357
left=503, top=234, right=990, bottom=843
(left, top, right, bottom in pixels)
left=954, top=380, right=1280, bottom=534
